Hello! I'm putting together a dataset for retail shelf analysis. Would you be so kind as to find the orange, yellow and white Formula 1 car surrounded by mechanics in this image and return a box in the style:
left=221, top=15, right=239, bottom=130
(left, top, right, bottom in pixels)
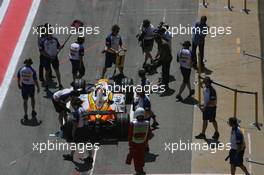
left=63, top=78, right=133, bottom=141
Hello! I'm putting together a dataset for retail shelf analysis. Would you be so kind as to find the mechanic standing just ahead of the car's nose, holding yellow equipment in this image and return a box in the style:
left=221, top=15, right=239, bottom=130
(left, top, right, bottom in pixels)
left=101, top=24, right=126, bottom=78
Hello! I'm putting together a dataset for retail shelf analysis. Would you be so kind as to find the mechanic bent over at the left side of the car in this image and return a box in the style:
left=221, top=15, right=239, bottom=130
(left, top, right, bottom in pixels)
left=52, top=88, right=77, bottom=130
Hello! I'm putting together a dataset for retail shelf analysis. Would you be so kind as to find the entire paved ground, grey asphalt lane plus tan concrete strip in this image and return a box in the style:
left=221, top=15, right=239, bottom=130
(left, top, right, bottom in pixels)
left=0, top=0, right=264, bottom=175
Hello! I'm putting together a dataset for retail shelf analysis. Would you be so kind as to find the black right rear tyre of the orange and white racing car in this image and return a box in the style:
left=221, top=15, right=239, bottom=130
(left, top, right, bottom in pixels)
left=116, top=113, right=130, bottom=141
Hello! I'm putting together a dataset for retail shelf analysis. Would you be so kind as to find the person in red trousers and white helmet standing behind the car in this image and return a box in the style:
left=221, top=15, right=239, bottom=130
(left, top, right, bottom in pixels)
left=126, top=108, right=150, bottom=175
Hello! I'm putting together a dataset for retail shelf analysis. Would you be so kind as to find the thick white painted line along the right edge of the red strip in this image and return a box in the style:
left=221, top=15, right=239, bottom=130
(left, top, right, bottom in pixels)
left=0, top=0, right=41, bottom=109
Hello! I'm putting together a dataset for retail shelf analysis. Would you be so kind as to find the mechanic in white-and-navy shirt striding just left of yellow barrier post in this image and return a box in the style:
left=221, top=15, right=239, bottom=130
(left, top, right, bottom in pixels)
left=176, top=41, right=195, bottom=101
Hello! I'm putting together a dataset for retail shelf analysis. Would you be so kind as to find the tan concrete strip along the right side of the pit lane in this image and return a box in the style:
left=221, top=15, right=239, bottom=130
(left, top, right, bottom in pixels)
left=192, top=0, right=264, bottom=175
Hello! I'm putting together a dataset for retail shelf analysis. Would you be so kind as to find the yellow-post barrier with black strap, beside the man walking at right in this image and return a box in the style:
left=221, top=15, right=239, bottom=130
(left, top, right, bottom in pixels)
left=198, top=55, right=262, bottom=130
